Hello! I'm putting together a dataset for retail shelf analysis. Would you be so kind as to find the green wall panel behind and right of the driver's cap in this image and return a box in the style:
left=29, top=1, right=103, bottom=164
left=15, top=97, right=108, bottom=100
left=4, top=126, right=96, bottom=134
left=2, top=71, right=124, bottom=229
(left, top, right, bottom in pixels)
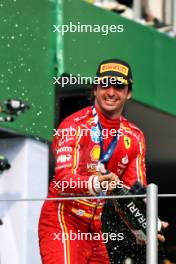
left=61, top=0, right=176, bottom=115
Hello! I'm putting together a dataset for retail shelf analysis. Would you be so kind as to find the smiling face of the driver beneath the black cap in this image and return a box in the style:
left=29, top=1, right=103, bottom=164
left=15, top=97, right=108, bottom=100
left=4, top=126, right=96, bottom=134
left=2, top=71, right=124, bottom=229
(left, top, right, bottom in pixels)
left=94, top=84, right=131, bottom=119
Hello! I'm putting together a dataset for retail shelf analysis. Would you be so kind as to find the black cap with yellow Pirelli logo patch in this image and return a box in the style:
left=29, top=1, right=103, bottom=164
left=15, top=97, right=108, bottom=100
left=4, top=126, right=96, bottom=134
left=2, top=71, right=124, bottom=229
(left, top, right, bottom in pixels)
left=96, top=59, right=133, bottom=85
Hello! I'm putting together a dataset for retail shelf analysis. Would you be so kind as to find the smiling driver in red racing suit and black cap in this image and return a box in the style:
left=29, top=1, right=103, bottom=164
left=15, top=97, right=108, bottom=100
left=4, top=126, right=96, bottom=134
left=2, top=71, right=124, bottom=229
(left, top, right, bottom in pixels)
left=39, top=59, right=166, bottom=264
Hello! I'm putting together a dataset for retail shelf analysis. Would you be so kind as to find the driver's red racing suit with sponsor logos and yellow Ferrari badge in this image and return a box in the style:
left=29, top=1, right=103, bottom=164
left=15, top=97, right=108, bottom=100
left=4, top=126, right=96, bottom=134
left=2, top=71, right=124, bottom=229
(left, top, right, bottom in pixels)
left=39, top=107, right=146, bottom=264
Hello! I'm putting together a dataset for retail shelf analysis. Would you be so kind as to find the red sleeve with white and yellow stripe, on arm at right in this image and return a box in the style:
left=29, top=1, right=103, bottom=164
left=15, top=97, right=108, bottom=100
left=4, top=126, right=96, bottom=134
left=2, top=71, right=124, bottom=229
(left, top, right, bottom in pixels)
left=122, top=132, right=147, bottom=187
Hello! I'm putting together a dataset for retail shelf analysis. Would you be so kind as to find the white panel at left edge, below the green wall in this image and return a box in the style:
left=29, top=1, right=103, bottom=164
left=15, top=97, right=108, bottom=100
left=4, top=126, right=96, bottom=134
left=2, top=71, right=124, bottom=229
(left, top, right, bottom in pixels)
left=0, top=137, right=49, bottom=264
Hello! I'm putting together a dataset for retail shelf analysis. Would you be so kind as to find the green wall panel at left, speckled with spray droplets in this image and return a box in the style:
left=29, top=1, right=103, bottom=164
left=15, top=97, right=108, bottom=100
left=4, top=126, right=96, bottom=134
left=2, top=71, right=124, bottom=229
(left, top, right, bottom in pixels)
left=0, top=0, right=56, bottom=140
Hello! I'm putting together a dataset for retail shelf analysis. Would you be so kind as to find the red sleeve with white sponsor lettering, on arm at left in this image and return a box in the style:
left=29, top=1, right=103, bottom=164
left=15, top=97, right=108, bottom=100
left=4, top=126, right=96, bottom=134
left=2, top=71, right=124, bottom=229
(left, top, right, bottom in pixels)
left=50, top=120, right=101, bottom=195
